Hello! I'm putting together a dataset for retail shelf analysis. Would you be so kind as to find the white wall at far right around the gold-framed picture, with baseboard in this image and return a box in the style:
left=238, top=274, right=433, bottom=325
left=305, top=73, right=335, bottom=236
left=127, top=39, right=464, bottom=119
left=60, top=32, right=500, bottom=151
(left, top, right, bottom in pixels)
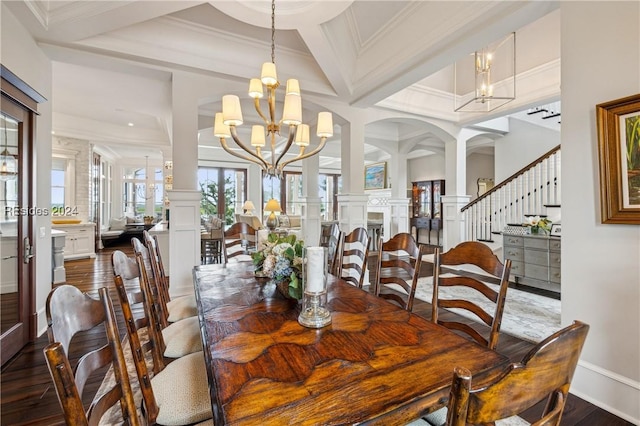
left=561, top=1, right=640, bottom=424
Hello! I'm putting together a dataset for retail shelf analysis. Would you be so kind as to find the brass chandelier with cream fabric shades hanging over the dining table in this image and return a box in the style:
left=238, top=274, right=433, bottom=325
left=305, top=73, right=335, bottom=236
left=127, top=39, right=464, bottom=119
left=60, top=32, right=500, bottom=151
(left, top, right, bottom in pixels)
left=213, top=0, right=333, bottom=178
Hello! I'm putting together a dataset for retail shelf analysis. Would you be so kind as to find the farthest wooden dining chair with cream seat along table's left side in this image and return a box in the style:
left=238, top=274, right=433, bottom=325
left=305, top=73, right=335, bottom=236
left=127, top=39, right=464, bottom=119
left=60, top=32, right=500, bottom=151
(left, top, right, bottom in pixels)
left=131, top=232, right=198, bottom=326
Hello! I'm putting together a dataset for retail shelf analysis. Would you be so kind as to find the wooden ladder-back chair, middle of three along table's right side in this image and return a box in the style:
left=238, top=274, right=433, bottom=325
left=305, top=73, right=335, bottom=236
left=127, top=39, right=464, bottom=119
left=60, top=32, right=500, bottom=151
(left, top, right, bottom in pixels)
left=374, top=233, right=422, bottom=311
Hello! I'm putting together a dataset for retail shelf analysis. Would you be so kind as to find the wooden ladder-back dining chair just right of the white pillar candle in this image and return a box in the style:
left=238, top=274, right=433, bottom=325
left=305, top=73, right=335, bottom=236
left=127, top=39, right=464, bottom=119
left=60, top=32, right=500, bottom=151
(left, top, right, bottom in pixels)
left=338, top=227, right=369, bottom=288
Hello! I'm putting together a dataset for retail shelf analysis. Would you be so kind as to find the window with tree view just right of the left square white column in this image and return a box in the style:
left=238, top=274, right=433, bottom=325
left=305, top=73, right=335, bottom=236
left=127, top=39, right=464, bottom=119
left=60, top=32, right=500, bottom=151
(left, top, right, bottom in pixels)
left=198, top=167, right=247, bottom=225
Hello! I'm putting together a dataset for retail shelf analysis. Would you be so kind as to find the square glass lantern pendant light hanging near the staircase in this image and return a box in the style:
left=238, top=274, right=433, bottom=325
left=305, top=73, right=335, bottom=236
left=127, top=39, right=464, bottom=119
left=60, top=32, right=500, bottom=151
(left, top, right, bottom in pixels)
left=454, top=33, right=516, bottom=112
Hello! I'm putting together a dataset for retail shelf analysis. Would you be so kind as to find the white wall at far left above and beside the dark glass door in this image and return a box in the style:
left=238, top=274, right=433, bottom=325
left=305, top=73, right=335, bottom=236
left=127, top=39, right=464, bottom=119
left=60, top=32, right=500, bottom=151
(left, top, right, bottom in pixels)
left=0, top=2, right=52, bottom=334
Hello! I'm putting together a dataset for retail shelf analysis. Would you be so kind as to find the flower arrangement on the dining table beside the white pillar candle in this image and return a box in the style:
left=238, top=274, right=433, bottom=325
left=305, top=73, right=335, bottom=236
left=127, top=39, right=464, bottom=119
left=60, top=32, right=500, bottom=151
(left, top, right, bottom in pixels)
left=251, top=234, right=304, bottom=299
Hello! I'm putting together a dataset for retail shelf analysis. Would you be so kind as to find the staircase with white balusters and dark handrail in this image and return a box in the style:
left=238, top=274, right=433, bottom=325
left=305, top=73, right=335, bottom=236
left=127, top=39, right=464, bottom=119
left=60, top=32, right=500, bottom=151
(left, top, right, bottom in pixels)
left=461, top=145, right=561, bottom=245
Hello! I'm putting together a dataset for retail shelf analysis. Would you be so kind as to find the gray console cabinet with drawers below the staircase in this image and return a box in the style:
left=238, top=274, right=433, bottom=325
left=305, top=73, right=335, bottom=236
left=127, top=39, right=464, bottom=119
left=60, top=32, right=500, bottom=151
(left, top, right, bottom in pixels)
left=503, top=234, right=561, bottom=293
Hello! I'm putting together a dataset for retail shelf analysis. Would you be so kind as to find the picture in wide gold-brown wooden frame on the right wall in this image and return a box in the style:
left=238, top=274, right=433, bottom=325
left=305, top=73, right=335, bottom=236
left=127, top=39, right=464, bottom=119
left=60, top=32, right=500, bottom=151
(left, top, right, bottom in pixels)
left=596, top=94, right=640, bottom=224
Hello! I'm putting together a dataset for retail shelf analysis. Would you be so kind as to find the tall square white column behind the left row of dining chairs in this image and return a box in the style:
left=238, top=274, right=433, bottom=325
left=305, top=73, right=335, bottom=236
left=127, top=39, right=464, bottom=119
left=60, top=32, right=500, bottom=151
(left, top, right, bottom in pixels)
left=167, top=73, right=201, bottom=296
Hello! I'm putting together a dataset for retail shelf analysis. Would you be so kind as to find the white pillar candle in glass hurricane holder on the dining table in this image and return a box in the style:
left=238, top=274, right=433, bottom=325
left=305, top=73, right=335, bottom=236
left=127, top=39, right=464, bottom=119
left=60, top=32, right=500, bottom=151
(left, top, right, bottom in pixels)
left=298, top=247, right=331, bottom=328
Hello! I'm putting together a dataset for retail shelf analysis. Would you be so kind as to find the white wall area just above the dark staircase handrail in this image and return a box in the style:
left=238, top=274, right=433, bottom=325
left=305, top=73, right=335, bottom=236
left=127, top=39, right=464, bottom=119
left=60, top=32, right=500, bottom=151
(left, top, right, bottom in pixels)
left=495, top=118, right=565, bottom=183
